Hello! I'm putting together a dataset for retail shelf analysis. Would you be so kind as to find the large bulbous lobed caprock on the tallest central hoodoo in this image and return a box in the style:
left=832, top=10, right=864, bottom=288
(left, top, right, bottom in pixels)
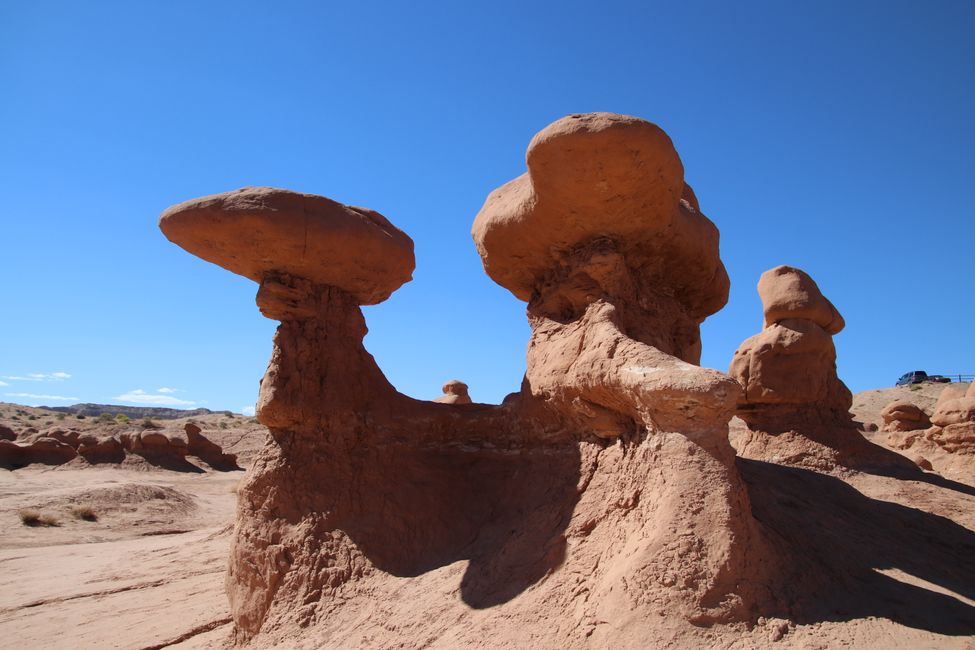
left=472, top=113, right=729, bottom=323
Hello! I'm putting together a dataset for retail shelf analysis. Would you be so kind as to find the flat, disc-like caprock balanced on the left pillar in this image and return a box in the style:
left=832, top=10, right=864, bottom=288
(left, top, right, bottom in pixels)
left=159, top=187, right=414, bottom=305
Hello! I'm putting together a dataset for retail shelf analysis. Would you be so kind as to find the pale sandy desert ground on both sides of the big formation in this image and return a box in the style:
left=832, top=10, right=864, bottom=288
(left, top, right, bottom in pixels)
left=0, top=384, right=975, bottom=650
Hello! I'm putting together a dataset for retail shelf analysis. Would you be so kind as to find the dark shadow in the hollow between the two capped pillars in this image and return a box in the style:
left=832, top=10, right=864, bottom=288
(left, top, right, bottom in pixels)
left=337, top=438, right=580, bottom=609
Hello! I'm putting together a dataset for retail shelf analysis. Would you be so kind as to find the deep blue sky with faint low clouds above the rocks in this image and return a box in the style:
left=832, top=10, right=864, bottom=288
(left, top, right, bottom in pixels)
left=0, top=0, right=975, bottom=411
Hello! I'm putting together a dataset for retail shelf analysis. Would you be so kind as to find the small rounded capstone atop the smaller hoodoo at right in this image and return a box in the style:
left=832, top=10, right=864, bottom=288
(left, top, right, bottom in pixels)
left=758, top=265, right=846, bottom=334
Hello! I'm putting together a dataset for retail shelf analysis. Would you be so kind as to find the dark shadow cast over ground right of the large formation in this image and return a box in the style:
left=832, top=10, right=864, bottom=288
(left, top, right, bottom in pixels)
left=737, top=458, right=975, bottom=635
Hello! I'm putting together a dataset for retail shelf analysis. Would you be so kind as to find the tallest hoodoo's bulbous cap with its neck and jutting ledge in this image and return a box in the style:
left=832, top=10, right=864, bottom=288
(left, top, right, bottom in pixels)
left=473, top=113, right=739, bottom=446
